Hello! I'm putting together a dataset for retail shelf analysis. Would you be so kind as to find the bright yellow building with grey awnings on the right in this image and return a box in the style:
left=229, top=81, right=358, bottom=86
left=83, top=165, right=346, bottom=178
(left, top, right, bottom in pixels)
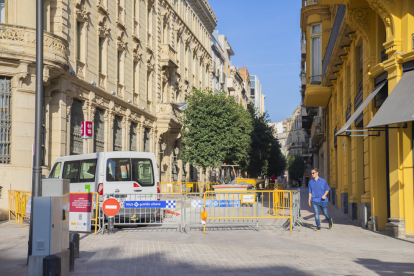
left=301, top=0, right=414, bottom=237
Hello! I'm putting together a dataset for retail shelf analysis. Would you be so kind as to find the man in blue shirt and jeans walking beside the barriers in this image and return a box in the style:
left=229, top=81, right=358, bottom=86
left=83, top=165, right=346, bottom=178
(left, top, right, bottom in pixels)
left=309, top=168, right=333, bottom=231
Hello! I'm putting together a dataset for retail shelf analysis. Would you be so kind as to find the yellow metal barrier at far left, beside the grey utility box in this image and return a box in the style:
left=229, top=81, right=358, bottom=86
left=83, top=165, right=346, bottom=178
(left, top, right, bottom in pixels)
left=8, top=190, right=32, bottom=227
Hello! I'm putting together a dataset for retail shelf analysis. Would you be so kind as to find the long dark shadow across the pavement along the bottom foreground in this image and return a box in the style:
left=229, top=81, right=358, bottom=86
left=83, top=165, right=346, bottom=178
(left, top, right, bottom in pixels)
left=70, top=252, right=309, bottom=276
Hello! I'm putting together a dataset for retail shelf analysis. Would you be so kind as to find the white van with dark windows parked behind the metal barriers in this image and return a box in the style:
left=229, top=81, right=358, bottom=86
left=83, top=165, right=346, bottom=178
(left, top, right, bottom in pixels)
left=49, top=151, right=159, bottom=198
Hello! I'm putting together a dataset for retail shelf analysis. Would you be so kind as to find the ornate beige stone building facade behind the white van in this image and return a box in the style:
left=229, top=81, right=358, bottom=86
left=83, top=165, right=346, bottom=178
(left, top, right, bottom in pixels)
left=0, top=0, right=217, bottom=219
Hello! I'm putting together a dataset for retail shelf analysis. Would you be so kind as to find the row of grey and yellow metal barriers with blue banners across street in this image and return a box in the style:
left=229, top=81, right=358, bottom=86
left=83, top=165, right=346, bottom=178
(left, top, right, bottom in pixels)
left=98, top=190, right=296, bottom=234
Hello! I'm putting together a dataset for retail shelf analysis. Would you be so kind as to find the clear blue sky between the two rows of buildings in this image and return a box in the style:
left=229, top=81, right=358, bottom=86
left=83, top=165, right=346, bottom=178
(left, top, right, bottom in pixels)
left=208, top=0, right=301, bottom=122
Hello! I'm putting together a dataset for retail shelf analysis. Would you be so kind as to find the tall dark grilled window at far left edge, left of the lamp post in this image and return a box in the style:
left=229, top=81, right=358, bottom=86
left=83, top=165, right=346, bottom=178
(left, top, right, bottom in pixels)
left=0, top=78, right=12, bottom=164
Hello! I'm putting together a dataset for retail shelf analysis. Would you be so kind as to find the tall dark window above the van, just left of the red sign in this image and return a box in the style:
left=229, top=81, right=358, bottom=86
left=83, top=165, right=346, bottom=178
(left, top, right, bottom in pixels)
left=70, top=99, right=84, bottom=154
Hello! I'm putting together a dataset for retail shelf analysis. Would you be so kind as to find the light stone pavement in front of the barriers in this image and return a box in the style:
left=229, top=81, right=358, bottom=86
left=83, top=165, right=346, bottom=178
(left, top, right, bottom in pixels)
left=0, top=189, right=414, bottom=276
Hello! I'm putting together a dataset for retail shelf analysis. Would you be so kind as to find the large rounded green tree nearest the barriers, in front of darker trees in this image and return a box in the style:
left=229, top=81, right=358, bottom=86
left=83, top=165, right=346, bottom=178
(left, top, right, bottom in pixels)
left=181, top=89, right=252, bottom=169
